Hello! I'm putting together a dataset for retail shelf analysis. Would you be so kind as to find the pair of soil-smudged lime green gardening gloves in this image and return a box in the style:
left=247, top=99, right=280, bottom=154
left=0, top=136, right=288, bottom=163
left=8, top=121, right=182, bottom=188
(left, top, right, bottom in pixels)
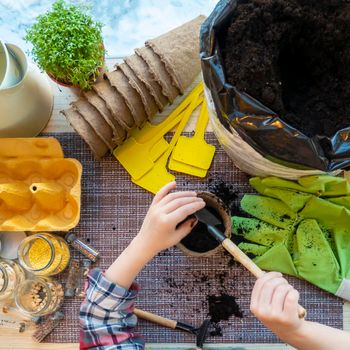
left=232, top=175, right=350, bottom=301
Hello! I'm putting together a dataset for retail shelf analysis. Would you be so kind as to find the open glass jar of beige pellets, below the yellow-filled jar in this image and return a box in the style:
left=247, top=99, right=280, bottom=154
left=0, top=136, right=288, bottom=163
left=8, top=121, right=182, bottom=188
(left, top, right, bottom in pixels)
left=15, top=277, right=64, bottom=316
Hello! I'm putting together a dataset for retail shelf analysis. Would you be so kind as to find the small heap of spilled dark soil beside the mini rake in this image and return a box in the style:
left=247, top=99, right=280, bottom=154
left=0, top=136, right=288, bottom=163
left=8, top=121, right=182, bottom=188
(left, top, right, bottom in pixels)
left=208, top=293, right=243, bottom=323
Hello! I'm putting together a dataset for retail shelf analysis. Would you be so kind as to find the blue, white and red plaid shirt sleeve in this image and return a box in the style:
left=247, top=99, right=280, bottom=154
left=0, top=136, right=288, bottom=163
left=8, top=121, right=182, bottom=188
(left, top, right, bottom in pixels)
left=80, top=269, right=144, bottom=350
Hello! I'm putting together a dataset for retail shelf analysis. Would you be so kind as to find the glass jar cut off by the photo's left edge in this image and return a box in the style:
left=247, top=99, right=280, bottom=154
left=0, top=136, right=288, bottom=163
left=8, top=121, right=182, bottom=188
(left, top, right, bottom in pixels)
left=0, top=259, right=25, bottom=302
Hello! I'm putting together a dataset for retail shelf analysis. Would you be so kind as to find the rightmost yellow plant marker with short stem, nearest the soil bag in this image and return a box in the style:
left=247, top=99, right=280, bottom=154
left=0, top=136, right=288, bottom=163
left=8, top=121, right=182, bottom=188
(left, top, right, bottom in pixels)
left=169, top=101, right=215, bottom=177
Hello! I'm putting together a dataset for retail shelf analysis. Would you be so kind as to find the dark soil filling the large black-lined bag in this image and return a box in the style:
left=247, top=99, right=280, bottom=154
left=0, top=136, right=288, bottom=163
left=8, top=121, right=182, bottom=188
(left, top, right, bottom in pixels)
left=220, top=0, right=350, bottom=136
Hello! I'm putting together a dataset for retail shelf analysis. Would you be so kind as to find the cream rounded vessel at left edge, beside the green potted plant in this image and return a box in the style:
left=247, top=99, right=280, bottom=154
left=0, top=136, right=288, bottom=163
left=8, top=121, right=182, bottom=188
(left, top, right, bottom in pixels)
left=0, top=41, right=53, bottom=137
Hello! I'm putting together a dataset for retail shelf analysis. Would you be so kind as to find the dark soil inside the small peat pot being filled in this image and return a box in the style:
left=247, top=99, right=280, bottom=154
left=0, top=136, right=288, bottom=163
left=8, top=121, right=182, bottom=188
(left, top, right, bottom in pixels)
left=181, top=206, right=225, bottom=253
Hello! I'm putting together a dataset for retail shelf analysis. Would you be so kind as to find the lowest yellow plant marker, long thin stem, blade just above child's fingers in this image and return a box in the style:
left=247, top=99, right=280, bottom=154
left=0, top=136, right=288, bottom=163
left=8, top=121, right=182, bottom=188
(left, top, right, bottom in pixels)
left=132, top=92, right=203, bottom=193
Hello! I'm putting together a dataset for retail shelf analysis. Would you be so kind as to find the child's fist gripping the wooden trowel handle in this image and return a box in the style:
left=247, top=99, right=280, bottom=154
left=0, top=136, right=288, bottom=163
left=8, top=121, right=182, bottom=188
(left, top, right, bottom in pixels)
left=250, top=272, right=305, bottom=338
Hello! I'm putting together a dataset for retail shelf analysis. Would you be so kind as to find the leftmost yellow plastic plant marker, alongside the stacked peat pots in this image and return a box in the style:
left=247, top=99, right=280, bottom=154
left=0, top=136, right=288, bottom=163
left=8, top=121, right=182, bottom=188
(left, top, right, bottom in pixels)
left=113, top=83, right=203, bottom=180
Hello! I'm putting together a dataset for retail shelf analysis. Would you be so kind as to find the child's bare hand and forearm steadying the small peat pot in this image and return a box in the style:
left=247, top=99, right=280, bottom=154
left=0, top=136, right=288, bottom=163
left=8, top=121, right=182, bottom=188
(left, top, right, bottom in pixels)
left=105, top=182, right=205, bottom=289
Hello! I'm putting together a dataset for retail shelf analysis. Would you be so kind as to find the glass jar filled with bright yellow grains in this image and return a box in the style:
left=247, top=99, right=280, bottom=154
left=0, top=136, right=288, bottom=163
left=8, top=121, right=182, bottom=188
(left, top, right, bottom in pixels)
left=18, top=233, right=70, bottom=276
